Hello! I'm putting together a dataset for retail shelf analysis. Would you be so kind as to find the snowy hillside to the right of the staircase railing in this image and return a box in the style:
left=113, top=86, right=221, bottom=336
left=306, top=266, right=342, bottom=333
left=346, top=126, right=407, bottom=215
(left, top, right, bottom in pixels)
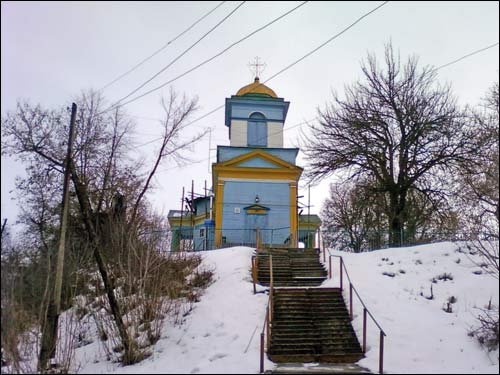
left=325, top=242, right=499, bottom=374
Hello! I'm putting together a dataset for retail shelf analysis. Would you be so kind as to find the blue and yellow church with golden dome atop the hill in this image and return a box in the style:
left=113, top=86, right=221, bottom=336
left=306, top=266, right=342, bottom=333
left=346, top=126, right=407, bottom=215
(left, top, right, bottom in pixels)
left=168, top=72, right=321, bottom=251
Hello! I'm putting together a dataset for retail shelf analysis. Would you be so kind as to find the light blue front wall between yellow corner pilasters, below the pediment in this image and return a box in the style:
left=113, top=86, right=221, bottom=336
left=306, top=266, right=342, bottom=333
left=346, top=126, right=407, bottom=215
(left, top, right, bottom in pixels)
left=222, top=181, right=290, bottom=244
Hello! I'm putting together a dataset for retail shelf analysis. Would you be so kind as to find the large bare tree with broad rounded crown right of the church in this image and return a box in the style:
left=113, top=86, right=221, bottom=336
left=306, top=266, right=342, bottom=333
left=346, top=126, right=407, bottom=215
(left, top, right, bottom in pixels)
left=305, top=45, right=470, bottom=246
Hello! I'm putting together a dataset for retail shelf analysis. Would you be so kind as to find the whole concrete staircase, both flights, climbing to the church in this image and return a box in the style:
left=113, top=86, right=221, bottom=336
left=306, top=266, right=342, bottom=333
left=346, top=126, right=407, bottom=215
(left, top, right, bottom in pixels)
left=256, top=249, right=363, bottom=372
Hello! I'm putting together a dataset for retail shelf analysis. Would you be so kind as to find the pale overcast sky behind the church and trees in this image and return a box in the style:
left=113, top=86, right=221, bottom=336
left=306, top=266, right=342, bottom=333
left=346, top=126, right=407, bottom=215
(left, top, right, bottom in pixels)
left=1, top=1, right=499, bottom=235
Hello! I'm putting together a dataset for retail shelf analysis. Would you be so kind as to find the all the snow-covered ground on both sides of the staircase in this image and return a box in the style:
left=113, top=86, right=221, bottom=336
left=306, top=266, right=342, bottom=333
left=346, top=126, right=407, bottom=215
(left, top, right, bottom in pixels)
left=75, top=243, right=499, bottom=374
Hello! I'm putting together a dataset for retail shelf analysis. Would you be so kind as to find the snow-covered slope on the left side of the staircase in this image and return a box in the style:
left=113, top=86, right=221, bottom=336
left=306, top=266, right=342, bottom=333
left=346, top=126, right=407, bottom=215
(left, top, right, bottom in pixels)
left=76, top=247, right=273, bottom=374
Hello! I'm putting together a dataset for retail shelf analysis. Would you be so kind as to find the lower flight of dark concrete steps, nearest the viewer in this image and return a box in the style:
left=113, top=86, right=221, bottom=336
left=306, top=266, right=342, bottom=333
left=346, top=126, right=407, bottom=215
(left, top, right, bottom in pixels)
left=268, top=288, right=363, bottom=363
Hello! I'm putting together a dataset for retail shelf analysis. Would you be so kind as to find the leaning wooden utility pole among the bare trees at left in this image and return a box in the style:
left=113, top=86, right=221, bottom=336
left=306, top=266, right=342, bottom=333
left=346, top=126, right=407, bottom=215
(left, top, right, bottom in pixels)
left=38, top=103, right=76, bottom=372
